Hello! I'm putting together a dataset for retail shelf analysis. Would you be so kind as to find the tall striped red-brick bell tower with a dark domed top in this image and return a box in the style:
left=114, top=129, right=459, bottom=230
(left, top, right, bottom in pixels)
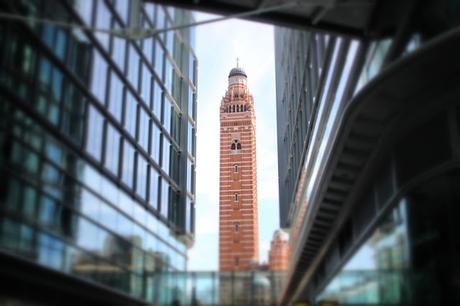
left=219, top=62, right=259, bottom=271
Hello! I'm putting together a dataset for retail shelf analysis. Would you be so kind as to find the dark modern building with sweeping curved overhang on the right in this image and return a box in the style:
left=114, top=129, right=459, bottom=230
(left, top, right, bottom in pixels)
left=275, top=1, right=460, bottom=305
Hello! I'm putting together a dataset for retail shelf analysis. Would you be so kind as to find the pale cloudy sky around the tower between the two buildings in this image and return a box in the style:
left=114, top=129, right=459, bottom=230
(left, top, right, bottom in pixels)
left=188, top=13, right=279, bottom=271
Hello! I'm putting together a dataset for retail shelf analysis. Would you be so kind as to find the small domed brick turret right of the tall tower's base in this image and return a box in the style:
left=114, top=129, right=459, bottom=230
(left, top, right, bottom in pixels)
left=268, top=230, right=289, bottom=271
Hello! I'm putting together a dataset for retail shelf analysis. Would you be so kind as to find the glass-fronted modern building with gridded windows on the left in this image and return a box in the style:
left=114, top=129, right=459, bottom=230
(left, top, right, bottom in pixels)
left=0, top=0, right=197, bottom=305
